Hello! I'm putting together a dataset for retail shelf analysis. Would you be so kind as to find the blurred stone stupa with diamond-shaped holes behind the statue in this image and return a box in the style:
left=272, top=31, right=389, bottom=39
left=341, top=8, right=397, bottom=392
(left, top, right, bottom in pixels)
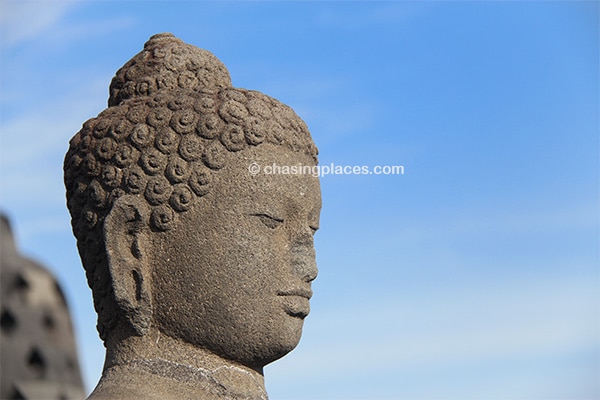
left=0, top=215, right=85, bottom=400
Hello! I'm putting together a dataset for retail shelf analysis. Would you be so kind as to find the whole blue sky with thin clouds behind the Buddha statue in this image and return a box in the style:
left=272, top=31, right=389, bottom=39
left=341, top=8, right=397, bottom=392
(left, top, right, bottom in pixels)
left=0, top=0, right=600, bottom=400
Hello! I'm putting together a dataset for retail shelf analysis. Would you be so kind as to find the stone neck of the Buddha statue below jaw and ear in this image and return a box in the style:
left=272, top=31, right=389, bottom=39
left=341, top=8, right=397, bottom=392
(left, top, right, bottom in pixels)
left=90, top=332, right=267, bottom=400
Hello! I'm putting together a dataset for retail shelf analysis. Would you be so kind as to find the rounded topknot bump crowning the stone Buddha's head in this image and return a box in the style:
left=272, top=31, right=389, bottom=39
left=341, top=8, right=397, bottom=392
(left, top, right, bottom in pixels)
left=108, top=33, right=232, bottom=107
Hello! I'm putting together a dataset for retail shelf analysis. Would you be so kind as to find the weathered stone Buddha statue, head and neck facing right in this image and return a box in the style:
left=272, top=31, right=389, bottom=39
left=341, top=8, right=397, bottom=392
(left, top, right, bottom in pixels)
left=64, top=34, right=321, bottom=399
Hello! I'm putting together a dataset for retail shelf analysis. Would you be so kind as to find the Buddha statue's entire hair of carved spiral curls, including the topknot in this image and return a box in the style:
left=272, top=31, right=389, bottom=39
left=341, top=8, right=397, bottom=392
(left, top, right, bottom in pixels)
left=64, top=33, right=318, bottom=340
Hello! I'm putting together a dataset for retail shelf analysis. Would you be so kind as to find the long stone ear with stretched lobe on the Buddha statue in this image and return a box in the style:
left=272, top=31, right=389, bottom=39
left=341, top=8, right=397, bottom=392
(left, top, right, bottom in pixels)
left=104, top=195, right=152, bottom=335
